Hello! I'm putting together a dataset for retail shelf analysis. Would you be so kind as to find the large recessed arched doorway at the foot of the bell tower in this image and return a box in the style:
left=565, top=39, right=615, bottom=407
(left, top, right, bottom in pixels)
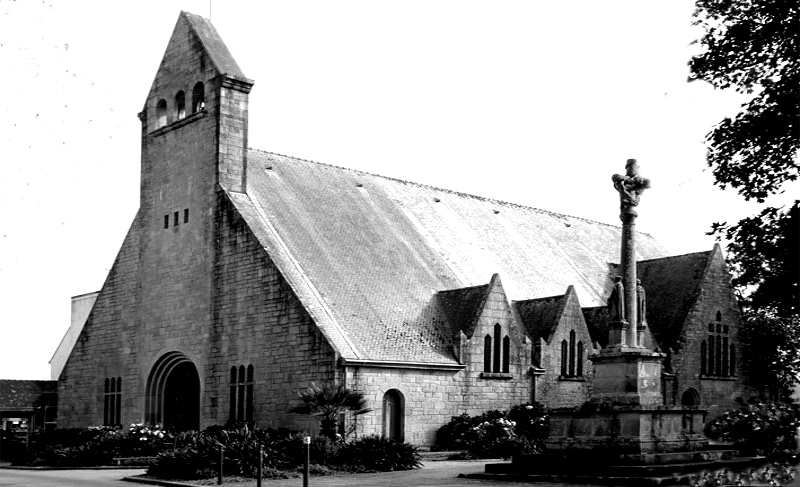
left=145, top=352, right=200, bottom=431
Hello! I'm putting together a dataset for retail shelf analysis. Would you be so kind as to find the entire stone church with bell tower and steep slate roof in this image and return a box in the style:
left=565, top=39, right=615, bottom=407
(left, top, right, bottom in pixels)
left=58, top=12, right=750, bottom=446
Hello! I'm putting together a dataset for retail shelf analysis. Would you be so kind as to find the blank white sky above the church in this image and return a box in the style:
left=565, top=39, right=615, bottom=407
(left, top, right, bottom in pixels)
left=0, top=0, right=789, bottom=379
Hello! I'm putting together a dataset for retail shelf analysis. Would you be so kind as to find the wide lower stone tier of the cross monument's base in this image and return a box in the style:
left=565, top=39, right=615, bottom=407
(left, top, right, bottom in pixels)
left=547, top=406, right=708, bottom=463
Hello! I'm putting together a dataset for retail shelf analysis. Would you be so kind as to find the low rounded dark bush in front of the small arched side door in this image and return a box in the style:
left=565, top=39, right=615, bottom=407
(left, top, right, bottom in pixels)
left=337, top=436, right=422, bottom=472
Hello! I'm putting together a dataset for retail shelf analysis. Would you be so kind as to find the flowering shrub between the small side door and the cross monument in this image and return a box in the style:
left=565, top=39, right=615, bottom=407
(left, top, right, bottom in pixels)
left=436, top=403, right=549, bottom=458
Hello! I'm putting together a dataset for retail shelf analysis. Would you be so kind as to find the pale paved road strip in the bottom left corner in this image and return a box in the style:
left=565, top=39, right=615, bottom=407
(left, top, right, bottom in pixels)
left=0, top=469, right=144, bottom=487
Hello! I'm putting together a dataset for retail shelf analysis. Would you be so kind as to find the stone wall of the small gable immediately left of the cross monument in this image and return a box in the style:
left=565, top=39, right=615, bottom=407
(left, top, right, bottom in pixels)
left=536, top=295, right=594, bottom=408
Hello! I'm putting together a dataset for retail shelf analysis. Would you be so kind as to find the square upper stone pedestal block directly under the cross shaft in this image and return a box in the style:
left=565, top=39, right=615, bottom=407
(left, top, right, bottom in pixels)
left=589, top=346, right=664, bottom=407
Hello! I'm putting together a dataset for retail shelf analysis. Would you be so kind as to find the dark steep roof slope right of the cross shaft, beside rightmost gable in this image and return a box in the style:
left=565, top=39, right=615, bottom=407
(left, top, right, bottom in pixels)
left=608, top=250, right=714, bottom=350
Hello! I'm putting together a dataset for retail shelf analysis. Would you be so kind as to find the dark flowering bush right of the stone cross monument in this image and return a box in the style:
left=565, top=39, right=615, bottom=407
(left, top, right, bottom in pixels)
left=705, top=400, right=800, bottom=456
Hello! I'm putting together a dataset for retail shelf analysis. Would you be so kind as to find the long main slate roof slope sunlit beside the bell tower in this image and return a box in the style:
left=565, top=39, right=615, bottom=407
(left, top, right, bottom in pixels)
left=227, top=149, right=666, bottom=363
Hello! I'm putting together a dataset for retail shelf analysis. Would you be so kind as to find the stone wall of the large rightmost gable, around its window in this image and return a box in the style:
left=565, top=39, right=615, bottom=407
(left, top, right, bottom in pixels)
left=673, top=250, right=757, bottom=420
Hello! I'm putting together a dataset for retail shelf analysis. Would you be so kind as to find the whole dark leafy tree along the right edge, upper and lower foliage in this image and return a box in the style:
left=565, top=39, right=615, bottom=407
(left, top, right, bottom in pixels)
left=689, top=0, right=800, bottom=396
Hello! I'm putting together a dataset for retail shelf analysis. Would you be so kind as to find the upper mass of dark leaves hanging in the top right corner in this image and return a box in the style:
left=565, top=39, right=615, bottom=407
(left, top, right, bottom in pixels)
left=689, top=0, right=800, bottom=201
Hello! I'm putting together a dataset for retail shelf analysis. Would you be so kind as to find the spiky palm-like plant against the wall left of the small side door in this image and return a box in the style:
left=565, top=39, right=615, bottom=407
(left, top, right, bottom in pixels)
left=290, top=382, right=372, bottom=440
